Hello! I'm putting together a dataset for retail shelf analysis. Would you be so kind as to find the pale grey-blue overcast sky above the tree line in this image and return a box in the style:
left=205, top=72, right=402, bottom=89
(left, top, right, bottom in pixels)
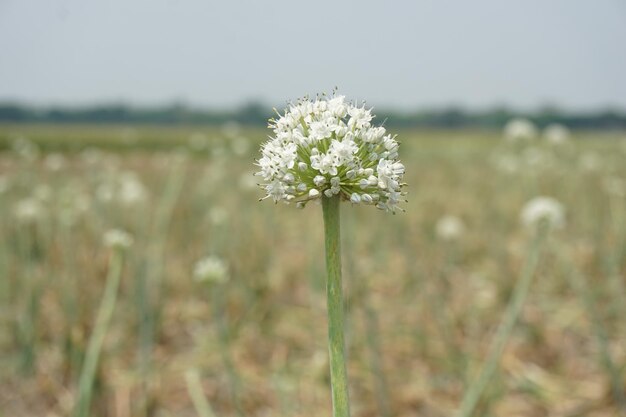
left=0, top=0, right=626, bottom=109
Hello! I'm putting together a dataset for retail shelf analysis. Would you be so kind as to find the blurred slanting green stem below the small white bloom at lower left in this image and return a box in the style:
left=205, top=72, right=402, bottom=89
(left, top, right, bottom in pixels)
left=74, top=249, right=123, bottom=417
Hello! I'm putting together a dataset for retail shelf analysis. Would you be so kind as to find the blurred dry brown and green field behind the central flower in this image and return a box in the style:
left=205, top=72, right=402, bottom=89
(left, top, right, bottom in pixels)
left=0, top=125, right=626, bottom=417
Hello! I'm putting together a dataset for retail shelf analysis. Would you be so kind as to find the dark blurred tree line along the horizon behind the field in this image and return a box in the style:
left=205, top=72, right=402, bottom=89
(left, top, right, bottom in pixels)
left=0, top=102, right=626, bottom=129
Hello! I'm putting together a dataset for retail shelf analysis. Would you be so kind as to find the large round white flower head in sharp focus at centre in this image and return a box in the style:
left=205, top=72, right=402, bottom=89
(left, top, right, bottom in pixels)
left=255, top=96, right=406, bottom=213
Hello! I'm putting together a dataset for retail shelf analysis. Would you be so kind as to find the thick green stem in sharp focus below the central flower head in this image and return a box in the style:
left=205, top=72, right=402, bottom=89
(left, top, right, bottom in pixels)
left=322, top=196, right=350, bottom=417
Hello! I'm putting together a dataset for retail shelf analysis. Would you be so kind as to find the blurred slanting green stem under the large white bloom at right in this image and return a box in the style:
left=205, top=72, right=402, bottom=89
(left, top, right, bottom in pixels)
left=457, top=227, right=548, bottom=417
